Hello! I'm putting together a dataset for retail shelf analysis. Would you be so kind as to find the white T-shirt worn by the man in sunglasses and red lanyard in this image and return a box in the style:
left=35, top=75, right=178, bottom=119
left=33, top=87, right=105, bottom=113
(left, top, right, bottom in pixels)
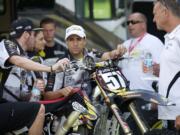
left=120, top=33, right=164, bottom=91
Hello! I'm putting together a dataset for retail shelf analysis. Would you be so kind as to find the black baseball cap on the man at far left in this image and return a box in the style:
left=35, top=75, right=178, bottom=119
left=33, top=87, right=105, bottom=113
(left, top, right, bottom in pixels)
left=10, top=18, right=42, bottom=38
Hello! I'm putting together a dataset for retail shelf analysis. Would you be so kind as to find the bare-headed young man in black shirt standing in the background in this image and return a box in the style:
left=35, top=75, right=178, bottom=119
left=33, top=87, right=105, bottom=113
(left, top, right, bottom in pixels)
left=40, top=18, right=67, bottom=59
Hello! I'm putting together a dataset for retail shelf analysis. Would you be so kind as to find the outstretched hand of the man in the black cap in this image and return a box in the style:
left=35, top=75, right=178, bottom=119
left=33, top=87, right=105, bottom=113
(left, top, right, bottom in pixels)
left=51, top=58, right=69, bottom=72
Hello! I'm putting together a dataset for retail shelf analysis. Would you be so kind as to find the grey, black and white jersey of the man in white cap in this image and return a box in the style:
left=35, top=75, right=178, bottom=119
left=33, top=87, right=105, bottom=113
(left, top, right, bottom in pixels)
left=46, top=49, right=103, bottom=96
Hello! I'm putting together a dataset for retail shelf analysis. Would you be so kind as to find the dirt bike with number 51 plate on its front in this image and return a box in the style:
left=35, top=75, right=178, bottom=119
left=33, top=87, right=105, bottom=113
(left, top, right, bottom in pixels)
left=73, top=57, right=174, bottom=135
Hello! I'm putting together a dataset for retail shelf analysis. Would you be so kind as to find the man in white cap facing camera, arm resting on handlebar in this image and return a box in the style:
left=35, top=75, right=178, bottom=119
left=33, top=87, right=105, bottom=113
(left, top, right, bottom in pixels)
left=45, top=25, right=125, bottom=99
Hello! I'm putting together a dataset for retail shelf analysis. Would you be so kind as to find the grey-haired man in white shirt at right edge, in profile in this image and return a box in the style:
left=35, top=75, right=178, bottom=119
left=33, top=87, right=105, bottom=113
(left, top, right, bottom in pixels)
left=153, top=0, right=180, bottom=130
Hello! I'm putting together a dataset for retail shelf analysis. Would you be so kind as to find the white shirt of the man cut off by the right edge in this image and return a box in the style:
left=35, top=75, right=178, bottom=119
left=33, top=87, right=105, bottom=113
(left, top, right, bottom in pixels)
left=158, top=25, right=180, bottom=120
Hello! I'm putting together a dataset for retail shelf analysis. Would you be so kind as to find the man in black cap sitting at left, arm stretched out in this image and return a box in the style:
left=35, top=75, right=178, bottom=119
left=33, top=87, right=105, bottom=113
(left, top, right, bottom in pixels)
left=0, top=19, right=69, bottom=135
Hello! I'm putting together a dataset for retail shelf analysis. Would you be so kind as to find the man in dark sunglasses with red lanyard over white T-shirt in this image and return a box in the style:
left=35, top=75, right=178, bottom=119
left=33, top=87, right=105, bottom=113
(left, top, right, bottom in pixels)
left=118, top=12, right=163, bottom=134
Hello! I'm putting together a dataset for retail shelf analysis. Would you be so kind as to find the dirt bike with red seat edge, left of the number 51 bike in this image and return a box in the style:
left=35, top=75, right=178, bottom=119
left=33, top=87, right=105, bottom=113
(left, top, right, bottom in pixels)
left=6, top=88, right=97, bottom=135
